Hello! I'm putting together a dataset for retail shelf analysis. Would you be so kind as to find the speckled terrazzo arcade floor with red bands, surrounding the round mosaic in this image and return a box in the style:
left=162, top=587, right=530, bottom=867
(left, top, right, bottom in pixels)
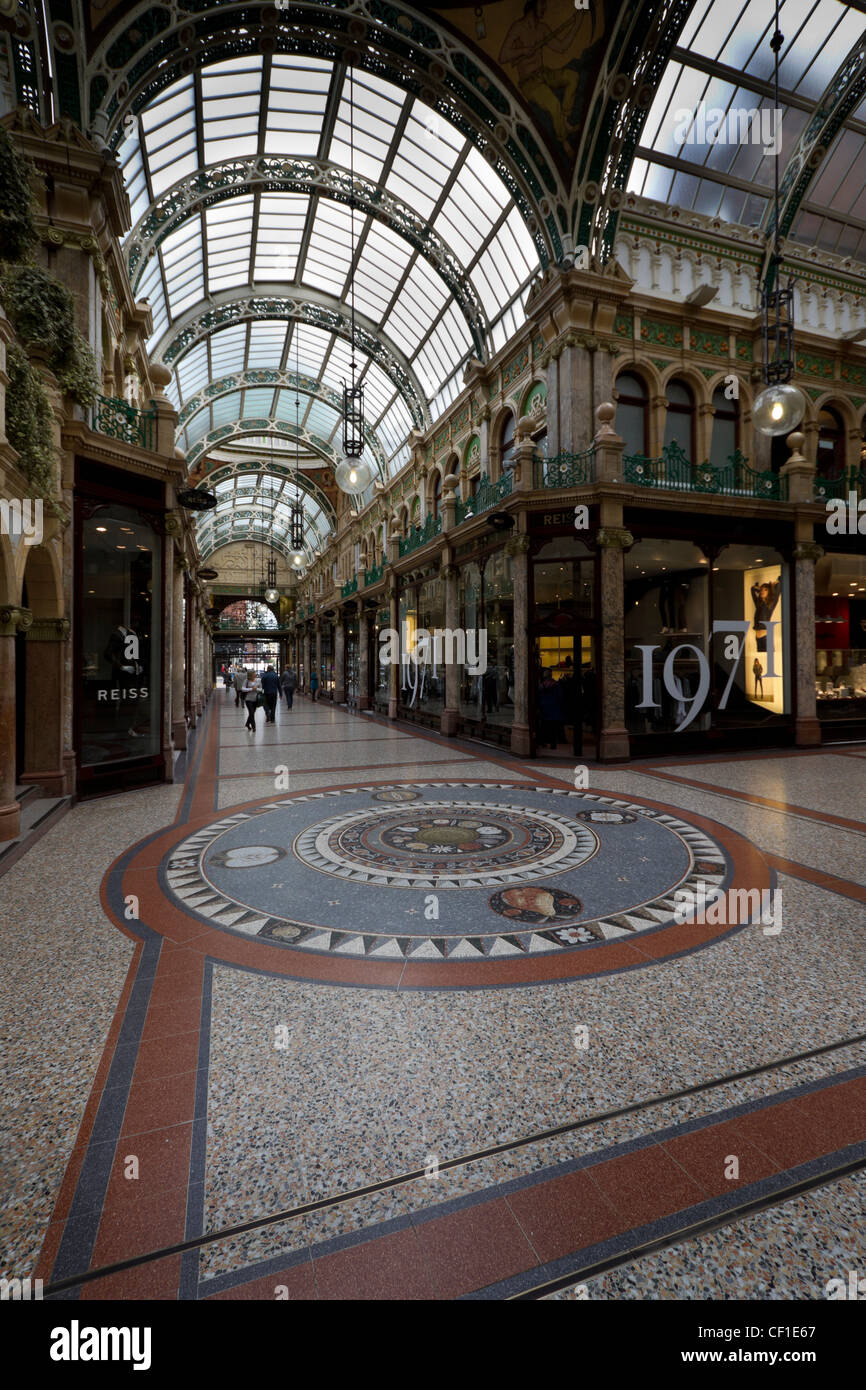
left=0, top=691, right=866, bottom=1300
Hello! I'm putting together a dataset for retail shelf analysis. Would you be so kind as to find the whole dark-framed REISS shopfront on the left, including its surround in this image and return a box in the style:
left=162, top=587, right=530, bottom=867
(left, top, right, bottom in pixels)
left=74, top=461, right=167, bottom=795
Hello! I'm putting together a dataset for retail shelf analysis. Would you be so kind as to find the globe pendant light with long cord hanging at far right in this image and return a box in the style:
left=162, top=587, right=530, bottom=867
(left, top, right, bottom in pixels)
left=752, top=0, right=806, bottom=435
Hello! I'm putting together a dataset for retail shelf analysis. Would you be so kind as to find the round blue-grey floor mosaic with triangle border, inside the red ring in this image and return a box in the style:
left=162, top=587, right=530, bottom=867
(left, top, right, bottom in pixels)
left=163, top=783, right=733, bottom=963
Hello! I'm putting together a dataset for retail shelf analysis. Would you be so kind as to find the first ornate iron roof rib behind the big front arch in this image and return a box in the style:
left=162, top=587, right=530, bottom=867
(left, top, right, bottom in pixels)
left=126, top=154, right=488, bottom=360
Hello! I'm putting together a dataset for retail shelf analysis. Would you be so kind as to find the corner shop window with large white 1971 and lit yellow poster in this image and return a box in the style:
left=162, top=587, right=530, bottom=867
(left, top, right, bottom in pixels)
left=624, top=517, right=795, bottom=755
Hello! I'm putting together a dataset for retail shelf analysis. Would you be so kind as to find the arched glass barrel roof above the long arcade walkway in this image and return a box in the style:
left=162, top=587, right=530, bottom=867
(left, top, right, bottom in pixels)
left=120, top=54, right=539, bottom=473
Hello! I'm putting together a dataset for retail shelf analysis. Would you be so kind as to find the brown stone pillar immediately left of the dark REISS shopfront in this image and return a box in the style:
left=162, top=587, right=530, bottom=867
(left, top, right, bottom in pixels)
left=20, top=617, right=72, bottom=796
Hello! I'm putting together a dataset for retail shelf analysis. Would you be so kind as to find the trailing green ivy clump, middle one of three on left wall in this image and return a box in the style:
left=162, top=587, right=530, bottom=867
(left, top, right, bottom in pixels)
left=0, top=265, right=97, bottom=407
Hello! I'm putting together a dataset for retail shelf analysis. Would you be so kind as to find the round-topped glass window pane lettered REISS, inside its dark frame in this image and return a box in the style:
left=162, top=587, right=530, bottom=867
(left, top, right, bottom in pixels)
left=79, top=503, right=163, bottom=767
